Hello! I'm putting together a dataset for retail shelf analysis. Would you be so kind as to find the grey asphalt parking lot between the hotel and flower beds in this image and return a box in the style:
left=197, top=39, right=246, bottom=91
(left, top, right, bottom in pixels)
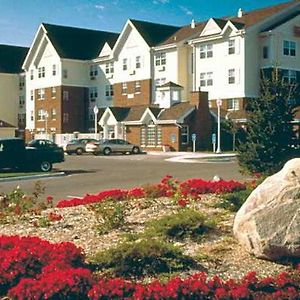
left=0, top=154, right=246, bottom=200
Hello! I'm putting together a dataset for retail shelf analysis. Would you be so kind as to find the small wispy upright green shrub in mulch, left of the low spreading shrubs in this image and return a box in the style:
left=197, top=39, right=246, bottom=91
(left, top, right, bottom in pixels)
left=89, top=199, right=129, bottom=234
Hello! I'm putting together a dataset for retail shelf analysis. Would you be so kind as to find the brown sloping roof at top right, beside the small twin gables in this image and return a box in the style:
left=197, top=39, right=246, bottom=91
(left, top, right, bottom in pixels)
left=227, top=0, right=299, bottom=27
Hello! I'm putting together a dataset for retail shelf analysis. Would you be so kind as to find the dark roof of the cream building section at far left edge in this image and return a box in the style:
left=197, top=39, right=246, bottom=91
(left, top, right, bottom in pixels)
left=0, top=45, right=29, bottom=74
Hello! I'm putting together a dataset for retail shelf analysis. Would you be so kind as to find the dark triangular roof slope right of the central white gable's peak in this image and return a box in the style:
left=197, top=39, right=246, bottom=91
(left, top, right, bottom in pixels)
left=130, top=19, right=180, bottom=47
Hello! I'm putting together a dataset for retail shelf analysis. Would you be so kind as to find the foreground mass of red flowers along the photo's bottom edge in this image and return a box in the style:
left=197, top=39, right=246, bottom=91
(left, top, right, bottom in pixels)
left=0, top=236, right=300, bottom=300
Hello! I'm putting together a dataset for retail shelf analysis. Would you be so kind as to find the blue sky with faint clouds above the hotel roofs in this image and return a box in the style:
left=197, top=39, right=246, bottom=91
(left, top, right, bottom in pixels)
left=0, top=0, right=287, bottom=46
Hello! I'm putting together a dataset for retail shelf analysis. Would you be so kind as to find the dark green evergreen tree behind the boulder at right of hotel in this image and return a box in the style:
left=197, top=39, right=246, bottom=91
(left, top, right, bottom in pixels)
left=238, top=69, right=297, bottom=174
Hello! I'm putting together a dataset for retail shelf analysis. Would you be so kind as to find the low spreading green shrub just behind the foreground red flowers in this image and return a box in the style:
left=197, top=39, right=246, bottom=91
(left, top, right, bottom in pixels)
left=92, top=239, right=195, bottom=277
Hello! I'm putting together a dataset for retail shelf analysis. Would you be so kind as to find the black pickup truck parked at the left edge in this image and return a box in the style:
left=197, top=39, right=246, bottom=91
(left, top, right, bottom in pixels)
left=0, top=138, right=65, bottom=172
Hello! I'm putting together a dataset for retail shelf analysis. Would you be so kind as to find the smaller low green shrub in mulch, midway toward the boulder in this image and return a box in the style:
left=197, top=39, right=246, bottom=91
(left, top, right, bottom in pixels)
left=144, top=208, right=214, bottom=240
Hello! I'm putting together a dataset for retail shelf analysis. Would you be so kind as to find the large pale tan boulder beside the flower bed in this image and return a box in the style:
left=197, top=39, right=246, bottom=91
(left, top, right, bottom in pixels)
left=233, top=158, right=300, bottom=260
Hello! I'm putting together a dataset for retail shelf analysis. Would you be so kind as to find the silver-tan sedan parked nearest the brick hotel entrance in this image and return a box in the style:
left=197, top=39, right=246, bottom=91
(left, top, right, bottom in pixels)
left=85, top=139, right=140, bottom=155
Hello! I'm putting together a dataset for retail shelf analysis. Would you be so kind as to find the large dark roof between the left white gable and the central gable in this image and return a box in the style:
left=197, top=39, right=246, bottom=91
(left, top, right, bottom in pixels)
left=42, top=23, right=119, bottom=60
